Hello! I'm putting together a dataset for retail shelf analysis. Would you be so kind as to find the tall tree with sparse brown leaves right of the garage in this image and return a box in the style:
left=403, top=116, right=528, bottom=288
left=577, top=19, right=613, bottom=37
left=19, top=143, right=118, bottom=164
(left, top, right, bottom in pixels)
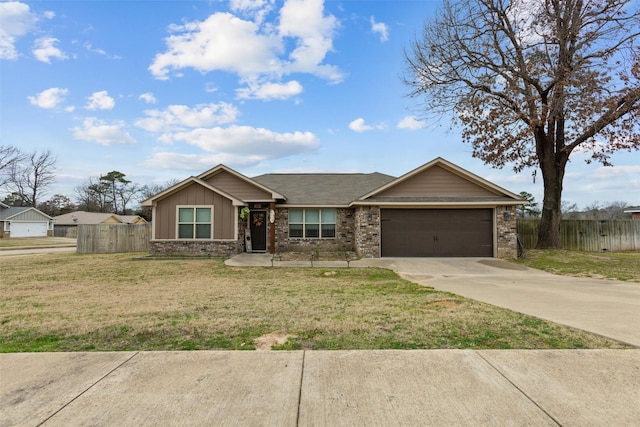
left=405, top=0, right=640, bottom=248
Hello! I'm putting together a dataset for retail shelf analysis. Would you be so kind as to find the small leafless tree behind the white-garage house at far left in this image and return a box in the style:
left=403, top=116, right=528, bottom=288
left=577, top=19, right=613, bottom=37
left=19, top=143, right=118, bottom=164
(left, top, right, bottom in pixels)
left=9, top=150, right=56, bottom=207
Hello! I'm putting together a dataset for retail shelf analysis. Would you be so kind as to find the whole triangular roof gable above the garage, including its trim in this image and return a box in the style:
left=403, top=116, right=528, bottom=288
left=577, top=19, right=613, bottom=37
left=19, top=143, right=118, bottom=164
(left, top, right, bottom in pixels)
left=359, top=157, right=521, bottom=201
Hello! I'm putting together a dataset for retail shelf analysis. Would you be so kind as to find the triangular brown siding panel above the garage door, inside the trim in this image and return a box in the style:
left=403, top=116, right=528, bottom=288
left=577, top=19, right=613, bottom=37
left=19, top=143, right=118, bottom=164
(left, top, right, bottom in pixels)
left=377, top=166, right=497, bottom=197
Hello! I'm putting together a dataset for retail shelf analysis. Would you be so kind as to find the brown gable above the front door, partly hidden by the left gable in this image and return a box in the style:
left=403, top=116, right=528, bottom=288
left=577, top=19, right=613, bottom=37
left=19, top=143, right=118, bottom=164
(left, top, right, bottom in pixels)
left=198, top=165, right=286, bottom=202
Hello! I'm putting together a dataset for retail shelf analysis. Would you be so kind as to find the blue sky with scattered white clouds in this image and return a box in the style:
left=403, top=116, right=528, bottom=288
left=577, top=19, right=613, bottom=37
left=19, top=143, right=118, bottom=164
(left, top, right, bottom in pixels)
left=0, top=0, right=640, bottom=208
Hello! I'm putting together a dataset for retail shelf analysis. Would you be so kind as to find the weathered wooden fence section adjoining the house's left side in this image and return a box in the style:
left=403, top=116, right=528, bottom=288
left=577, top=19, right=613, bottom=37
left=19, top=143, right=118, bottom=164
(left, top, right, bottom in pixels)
left=77, top=224, right=151, bottom=254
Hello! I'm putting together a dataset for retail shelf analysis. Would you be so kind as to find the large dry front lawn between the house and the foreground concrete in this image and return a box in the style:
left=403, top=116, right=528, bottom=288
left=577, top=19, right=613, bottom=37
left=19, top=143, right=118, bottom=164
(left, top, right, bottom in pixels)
left=0, top=253, right=632, bottom=352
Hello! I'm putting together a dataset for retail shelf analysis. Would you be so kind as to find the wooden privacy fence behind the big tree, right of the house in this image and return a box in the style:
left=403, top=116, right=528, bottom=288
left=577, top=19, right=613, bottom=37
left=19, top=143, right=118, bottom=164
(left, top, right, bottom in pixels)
left=518, top=219, right=640, bottom=252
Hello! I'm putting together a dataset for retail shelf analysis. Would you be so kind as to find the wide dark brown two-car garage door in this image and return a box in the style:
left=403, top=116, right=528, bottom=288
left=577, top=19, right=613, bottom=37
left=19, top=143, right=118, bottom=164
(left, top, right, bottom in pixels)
left=380, top=209, right=493, bottom=257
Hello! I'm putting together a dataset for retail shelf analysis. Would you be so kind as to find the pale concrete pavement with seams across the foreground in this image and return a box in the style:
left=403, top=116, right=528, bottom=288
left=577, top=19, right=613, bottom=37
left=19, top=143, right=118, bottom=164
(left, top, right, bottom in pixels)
left=0, top=350, right=640, bottom=426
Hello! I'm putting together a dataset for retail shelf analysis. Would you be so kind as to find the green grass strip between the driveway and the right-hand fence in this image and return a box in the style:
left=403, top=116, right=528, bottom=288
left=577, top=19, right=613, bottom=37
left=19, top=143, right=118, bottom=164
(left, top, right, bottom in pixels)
left=518, top=249, right=640, bottom=282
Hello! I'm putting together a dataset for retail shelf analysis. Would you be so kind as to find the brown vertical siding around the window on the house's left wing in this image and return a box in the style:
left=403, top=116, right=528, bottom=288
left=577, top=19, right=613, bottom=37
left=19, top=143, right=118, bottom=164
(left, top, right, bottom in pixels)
left=153, top=184, right=235, bottom=239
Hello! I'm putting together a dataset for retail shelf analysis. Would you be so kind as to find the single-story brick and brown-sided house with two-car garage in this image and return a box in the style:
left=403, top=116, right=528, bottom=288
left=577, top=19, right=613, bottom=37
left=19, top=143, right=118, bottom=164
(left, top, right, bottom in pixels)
left=142, top=158, right=526, bottom=258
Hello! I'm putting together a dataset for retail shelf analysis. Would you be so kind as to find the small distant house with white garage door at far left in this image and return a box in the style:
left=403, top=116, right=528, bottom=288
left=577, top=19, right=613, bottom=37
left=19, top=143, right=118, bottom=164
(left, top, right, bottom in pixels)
left=0, top=202, right=53, bottom=239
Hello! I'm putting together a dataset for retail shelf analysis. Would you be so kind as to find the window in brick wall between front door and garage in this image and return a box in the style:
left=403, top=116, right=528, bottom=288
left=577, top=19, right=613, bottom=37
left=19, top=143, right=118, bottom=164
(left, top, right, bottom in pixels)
left=289, top=209, right=336, bottom=239
